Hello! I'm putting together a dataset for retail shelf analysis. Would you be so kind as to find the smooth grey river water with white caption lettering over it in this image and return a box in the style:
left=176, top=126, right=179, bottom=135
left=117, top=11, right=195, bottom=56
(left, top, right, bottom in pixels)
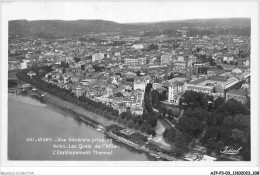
left=8, top=94, right=157, bottom=161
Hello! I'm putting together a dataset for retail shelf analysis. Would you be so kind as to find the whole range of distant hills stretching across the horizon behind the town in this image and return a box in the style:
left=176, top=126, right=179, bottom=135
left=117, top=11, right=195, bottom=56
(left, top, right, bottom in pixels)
left=9, top=18, right=250, bottom=37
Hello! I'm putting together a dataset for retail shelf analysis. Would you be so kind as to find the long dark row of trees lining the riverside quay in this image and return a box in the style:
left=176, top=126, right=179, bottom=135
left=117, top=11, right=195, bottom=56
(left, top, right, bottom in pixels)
left=17, top=68, right=158, bottom=135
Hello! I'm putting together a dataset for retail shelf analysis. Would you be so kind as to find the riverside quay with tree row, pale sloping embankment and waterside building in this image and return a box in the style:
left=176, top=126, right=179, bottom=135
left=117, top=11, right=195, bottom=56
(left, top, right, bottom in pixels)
left=17, top=68, right=185, bottom=160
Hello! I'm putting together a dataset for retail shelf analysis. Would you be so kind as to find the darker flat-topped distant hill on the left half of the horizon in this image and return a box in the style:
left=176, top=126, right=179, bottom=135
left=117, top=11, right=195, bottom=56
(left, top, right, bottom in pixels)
left=9, top=20, right=122, bottom=37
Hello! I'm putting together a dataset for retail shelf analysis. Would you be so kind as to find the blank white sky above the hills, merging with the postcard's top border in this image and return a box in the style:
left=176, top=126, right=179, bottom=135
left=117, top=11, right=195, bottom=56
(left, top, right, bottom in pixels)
left=2, top=1, right=255, bottom=23
